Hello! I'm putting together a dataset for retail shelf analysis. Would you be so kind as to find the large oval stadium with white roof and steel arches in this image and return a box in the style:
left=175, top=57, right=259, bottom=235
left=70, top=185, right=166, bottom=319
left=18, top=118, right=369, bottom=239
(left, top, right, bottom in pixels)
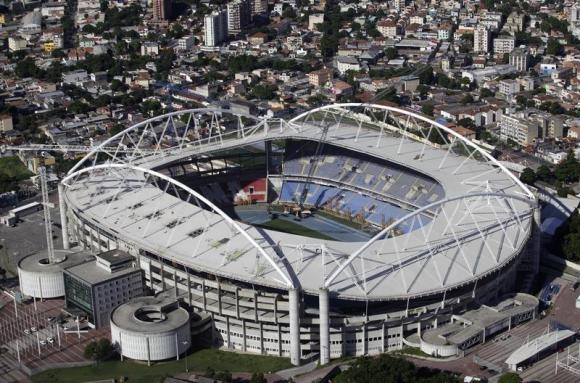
left=59, top=103, right=540, bottom=365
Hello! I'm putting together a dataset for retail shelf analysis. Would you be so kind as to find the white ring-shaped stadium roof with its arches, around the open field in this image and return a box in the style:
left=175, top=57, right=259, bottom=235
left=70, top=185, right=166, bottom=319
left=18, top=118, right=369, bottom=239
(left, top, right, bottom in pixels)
left=63, top=104, right=535, bottom=299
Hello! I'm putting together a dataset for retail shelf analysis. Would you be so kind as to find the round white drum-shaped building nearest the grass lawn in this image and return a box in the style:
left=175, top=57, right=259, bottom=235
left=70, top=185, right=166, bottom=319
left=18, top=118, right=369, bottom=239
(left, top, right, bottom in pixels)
left=111, top=296, right=191, bottom=362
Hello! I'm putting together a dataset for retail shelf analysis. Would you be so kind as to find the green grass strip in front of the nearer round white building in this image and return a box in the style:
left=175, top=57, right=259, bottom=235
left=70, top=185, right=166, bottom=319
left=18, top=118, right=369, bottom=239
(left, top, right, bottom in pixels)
left=32, top=349, right=292, bottom=383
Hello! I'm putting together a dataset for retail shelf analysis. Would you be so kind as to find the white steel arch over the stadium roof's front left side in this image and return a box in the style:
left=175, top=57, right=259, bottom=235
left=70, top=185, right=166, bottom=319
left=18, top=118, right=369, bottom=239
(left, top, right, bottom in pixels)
left=61, top=164, right=296, bottom=288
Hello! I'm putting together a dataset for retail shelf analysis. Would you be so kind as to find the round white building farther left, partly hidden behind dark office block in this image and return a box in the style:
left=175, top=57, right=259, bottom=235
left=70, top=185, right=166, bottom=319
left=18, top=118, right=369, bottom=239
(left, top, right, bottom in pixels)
left=18, top=250, right=84, bottom=299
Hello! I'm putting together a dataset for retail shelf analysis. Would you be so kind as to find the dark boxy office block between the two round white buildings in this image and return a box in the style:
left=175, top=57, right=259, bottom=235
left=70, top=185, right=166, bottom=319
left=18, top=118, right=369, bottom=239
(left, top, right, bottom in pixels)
left=64, top=250, right=145, bottom=328
